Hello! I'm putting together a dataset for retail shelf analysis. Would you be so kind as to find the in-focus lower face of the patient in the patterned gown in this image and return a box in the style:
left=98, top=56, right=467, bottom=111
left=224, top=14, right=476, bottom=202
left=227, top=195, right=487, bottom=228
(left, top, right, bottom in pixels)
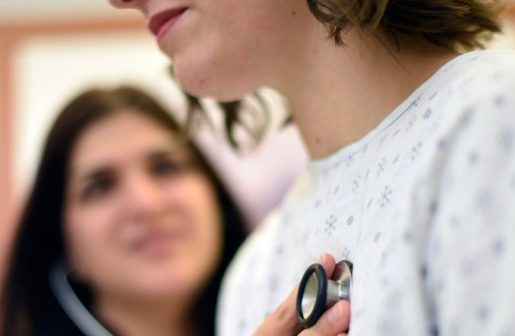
left=110, top=0, right=318, bottom=100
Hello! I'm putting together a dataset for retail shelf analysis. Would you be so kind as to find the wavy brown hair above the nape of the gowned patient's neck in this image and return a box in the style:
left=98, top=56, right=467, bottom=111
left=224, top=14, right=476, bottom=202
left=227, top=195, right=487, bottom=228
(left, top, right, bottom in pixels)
left=307, top=0, right=501, bottom=50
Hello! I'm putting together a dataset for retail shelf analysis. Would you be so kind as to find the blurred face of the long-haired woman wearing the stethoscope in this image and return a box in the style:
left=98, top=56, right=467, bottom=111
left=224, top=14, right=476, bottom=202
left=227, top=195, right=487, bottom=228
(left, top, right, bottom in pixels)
left=64, top=111, right=222, bottom=300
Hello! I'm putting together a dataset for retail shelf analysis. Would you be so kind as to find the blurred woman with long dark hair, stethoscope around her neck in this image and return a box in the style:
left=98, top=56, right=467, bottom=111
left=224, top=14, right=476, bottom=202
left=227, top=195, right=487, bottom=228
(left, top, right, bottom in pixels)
left=2, top=87, right=244, bottom=336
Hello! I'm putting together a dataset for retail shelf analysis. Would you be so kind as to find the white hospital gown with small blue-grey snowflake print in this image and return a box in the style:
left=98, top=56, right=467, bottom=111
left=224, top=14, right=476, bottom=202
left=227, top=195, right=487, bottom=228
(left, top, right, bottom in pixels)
left=218, top=51, right=515, bottom=336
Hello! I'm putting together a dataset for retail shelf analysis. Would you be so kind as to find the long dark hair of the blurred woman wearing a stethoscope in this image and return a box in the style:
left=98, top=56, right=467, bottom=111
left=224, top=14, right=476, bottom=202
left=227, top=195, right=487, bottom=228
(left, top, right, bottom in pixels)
left=0, top=87, right=245, bottom=336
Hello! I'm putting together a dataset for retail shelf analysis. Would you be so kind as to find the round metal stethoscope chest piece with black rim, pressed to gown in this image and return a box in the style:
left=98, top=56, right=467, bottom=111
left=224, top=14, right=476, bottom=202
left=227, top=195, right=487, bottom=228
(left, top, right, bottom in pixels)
left=296, top=260, right=352, bottom=328
